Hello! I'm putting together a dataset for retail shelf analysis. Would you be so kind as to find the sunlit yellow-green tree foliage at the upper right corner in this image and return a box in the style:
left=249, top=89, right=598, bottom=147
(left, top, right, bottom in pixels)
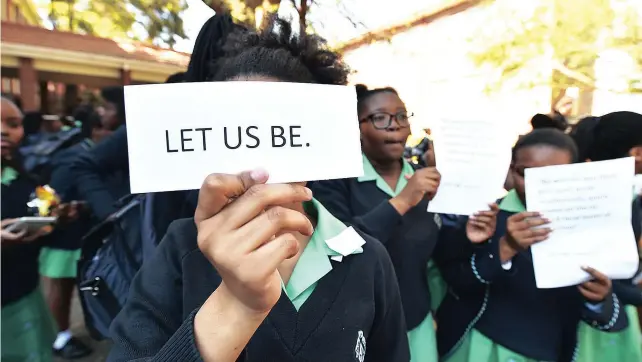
left=464, top=0, right=642, bottom=104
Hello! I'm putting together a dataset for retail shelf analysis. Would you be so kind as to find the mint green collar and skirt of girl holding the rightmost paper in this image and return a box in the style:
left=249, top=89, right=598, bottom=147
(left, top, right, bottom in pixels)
left=444, top=190, right=544, bottom=362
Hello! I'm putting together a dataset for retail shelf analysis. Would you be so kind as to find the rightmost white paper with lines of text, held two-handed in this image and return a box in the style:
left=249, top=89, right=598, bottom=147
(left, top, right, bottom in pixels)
left=525, top=158, right=638, bottom=288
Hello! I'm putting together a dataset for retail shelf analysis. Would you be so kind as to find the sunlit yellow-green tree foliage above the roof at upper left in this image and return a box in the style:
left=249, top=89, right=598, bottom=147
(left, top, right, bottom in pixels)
left=38, top=0, right=187, bottom=48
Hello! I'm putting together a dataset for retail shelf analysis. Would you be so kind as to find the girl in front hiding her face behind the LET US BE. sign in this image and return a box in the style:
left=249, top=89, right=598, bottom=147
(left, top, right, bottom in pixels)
left=109, top=20, right=409, bottom=362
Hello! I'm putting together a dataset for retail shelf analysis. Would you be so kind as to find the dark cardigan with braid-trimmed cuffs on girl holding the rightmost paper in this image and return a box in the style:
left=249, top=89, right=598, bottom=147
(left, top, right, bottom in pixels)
left=434, top=205, right=628, bottom=362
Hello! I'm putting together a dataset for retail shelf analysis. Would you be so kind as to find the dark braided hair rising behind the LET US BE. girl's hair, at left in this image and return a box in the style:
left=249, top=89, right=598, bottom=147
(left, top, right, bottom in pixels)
left=184, top=14, right=245, bottom=82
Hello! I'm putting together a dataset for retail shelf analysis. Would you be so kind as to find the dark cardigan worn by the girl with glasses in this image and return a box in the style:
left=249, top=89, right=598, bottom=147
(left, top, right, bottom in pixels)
left=309, top=178, right=440, bottom=330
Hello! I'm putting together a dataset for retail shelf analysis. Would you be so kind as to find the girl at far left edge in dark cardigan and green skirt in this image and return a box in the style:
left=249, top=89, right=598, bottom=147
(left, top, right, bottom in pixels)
left=0, top=97, right=56, bottom=362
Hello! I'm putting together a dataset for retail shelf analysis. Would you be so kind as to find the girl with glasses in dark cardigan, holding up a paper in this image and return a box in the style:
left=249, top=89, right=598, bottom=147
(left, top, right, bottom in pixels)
left=310, top=85, right=441, bottom=361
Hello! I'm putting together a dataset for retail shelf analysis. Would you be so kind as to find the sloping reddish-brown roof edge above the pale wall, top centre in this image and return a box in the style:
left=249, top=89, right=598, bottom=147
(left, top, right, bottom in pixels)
left=335, top=0, right=487, bottom=53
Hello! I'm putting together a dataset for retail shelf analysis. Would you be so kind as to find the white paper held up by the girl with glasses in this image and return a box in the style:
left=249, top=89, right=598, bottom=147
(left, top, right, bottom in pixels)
left=428, top=120, right=514, bottom=215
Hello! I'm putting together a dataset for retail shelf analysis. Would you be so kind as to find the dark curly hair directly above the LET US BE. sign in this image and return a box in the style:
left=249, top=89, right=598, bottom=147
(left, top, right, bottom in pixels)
left=210, top=16, right=349, bottom=85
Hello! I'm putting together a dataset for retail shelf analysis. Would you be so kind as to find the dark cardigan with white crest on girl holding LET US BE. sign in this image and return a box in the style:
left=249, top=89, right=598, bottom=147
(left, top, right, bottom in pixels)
left=108, top=219, right=410, bottom=362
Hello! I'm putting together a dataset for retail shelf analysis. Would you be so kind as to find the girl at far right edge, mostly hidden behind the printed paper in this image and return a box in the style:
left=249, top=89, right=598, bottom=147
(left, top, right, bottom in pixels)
left=571, top=112, right=642, bottom=362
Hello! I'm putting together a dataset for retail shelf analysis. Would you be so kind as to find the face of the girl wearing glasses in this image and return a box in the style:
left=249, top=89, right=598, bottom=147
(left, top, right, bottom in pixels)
left=359, top=92, right=411, bottom=162
